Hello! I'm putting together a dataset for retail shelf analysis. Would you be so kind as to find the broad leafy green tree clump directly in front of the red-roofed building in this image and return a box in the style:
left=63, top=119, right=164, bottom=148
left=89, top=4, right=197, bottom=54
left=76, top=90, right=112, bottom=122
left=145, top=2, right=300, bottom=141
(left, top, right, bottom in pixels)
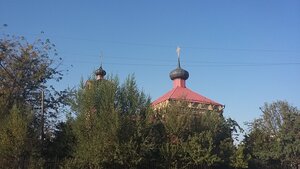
left=156, top=102, right=239, bottom=168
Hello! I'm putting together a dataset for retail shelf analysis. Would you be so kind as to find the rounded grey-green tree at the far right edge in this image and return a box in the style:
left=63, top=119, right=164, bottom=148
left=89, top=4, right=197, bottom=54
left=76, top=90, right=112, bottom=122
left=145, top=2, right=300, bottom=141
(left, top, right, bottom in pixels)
left=245, top=101, right=300, bottom=168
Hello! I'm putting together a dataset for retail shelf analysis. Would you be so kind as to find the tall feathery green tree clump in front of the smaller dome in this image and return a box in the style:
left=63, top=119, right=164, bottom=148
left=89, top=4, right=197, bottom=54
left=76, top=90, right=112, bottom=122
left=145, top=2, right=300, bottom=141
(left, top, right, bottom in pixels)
left=67, top=76, right=150, bottom=168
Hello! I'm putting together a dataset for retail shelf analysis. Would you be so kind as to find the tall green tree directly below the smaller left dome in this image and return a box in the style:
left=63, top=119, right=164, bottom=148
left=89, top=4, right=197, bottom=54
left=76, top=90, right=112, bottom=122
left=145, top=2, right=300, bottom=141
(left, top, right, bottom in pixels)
left=68, top=80, right=119, bottom=168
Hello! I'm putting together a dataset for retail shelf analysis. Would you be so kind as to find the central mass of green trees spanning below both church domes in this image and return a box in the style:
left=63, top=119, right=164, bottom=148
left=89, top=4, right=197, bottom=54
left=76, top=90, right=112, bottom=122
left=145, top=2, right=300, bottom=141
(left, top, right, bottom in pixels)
left=64, top=76, right=246, bottom=169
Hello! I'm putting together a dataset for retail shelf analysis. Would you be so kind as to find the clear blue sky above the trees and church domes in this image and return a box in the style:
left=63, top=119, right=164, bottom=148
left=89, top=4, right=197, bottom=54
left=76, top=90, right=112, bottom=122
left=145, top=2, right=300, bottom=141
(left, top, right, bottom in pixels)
left=0, top=0, right=300, bottom=137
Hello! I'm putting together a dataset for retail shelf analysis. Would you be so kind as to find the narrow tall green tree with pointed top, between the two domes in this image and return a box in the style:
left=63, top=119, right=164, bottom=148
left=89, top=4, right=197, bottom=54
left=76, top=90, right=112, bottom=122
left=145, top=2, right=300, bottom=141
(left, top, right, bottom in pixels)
left=115, top=75, right=150, bottom=168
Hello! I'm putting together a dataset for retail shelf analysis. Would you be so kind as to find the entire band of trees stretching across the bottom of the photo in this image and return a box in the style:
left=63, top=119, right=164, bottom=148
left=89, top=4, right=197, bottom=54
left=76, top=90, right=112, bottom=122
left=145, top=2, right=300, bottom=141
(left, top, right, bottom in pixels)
left=4, top=29, right=300, bottom=169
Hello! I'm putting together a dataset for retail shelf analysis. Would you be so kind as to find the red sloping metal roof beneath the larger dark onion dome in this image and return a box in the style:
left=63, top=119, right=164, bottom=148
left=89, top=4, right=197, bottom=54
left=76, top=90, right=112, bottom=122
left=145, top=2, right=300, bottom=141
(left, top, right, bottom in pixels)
left=152, top=87, right=221, bottom=106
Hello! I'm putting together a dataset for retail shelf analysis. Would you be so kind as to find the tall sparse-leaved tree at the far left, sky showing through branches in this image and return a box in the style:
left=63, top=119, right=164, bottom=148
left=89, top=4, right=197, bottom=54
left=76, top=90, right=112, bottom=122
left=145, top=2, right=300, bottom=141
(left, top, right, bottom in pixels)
left=0, top=31, right=68, bottom=167
